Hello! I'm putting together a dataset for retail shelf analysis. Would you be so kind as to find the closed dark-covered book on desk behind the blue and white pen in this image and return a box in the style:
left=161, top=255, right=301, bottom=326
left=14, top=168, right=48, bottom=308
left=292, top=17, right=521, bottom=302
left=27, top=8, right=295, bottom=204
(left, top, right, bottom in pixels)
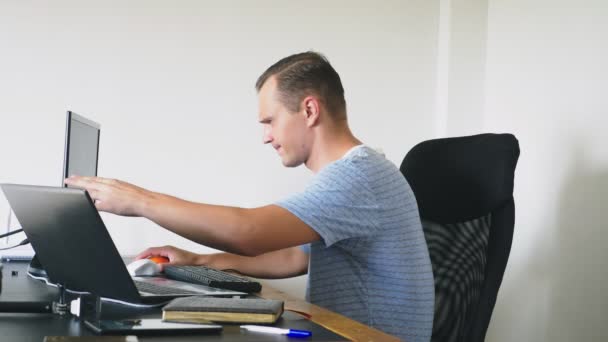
left=163, top=297, right=283, bottom=323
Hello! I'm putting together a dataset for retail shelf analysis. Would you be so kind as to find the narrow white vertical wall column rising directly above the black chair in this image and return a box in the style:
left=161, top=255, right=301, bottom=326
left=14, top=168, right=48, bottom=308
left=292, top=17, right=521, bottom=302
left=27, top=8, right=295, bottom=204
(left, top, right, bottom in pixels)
left=435, top=0, right=488, bottom=137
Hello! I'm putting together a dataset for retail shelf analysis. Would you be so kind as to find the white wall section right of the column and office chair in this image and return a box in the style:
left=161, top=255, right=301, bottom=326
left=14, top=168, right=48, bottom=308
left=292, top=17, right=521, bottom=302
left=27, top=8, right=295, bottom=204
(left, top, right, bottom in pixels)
left=483, top=0, right=608, bottom=341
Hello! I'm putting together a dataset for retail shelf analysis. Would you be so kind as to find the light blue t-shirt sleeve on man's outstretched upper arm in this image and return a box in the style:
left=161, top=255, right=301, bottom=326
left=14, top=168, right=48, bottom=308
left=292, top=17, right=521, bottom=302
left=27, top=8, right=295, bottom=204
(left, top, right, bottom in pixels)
left=275, top=162, right=378, bottom=246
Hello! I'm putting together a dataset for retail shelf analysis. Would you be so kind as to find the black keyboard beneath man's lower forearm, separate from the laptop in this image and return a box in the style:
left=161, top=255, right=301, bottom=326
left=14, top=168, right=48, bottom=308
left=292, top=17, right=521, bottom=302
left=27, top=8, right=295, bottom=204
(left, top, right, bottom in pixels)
left=164, top=265, right=262, bottom=293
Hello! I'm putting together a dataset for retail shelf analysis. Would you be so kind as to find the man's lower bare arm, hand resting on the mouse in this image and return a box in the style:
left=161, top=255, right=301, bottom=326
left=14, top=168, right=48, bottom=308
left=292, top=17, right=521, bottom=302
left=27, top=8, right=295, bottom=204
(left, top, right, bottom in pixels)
left=136, top=246, right=308, bottom=279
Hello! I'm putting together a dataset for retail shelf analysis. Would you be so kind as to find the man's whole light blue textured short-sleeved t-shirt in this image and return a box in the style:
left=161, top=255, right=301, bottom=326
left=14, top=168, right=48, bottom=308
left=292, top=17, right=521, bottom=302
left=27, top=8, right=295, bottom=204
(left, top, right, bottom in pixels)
left=276, top=146, right=434, bottom=342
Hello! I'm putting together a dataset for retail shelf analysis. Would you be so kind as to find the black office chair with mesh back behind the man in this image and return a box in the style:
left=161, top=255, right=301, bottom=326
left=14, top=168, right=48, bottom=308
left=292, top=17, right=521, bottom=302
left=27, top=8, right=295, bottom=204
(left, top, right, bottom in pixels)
left=400, top=134, right=519, bottom=342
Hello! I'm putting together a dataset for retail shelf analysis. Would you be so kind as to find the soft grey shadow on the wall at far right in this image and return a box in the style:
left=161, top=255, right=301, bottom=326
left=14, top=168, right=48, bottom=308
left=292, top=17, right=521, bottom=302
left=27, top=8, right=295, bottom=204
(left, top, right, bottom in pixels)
left=546, top=150, right=608, bottom=341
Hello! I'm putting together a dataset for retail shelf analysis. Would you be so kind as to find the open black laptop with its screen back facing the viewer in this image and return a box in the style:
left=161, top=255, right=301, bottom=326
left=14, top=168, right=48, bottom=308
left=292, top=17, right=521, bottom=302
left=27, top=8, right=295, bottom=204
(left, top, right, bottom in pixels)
left=0, top=184, right=247, bottom=303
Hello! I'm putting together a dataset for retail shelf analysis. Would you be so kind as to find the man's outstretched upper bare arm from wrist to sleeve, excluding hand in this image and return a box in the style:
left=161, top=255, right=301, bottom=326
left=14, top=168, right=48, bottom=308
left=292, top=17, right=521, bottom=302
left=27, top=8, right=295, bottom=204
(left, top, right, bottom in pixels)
left=140, top=195, right=319, bottom=256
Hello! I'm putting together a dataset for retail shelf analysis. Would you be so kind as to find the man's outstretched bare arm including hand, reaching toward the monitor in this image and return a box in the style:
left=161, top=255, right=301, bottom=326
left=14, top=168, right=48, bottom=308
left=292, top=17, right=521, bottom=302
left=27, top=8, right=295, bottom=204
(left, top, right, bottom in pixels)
left=65, top=177, right=320, bottom=256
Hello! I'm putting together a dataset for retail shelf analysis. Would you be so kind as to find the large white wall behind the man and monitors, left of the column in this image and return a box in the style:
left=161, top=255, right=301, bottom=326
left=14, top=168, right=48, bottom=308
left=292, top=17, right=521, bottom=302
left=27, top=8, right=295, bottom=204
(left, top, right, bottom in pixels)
left=0, top=0, right=438, bottom=296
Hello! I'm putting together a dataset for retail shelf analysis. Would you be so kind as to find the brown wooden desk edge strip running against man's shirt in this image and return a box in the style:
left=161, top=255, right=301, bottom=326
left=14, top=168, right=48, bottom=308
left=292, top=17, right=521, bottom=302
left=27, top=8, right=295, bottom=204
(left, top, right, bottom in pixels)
left=261, top=285, right=400, bottom=341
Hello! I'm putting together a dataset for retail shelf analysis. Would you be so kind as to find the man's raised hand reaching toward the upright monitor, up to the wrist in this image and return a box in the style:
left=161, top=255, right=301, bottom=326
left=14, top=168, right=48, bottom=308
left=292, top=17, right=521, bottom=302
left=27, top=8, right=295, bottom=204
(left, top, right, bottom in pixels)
left=65, top=176, right=155, bottom=216
